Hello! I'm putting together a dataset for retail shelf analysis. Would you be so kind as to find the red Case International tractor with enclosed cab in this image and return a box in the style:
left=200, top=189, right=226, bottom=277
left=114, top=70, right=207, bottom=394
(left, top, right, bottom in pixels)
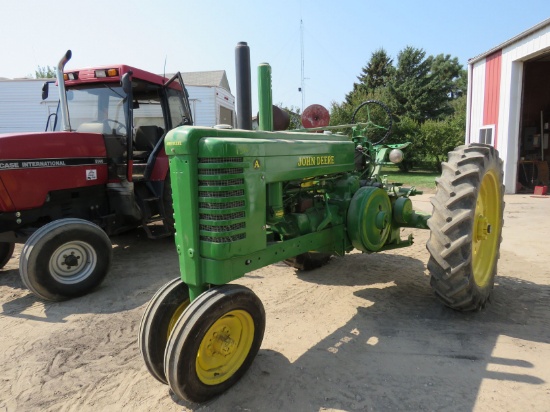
left=0, top=50, right=193, bottom=300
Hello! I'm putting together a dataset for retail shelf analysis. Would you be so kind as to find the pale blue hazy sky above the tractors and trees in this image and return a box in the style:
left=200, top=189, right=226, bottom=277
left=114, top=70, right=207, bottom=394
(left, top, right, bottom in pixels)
left=0, top=0, right=550, bottom=114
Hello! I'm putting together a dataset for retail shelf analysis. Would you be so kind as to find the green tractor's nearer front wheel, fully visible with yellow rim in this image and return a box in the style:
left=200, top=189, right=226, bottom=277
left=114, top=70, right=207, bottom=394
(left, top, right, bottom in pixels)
left=164, top=285, right=265, bottom=402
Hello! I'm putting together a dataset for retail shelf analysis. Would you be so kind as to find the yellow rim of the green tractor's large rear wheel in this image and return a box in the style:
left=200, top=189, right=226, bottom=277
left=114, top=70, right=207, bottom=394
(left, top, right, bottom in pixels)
left=472, top=171, right=502, bottom=288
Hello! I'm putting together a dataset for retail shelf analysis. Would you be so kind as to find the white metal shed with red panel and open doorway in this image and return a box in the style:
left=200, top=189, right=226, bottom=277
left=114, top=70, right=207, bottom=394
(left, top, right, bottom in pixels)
left=466, top=19, right=550, bottom=193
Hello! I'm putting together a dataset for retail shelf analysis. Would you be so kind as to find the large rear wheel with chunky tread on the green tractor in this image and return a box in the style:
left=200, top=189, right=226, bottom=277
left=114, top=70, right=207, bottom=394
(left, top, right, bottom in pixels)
left=427, top=144, right=504, bottom=311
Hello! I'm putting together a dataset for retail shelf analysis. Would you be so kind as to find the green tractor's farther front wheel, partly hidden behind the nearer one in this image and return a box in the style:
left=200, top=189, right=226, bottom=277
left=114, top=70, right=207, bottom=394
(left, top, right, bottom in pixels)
left=139, top=278, right=189, bottom=384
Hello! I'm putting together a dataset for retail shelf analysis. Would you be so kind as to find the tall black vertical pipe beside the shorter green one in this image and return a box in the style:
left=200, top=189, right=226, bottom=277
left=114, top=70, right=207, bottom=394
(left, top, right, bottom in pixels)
left=235, top=41, right=252, bottom=130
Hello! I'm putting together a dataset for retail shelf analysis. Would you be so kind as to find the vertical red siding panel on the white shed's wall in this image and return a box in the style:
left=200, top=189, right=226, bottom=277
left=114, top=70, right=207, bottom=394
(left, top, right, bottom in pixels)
left=483, top=50, right=502, bottom=148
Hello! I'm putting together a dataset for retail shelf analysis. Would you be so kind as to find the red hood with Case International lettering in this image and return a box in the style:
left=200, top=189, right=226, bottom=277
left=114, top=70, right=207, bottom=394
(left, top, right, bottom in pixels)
left=0, top=132, right=108, bottom=213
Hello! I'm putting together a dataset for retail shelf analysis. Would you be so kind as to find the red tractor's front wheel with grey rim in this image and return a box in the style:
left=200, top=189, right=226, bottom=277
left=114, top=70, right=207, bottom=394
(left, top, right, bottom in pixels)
left=19, top=218, right=113, bottom=301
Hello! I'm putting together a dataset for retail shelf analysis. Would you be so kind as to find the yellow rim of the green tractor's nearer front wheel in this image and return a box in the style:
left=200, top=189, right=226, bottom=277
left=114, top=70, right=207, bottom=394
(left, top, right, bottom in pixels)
left=196, top=310, right=254, bottom=385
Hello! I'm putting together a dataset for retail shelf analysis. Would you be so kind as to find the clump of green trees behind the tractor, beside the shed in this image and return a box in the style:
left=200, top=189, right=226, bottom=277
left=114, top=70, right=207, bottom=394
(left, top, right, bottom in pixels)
left=331, top=46, right=467, bottom=170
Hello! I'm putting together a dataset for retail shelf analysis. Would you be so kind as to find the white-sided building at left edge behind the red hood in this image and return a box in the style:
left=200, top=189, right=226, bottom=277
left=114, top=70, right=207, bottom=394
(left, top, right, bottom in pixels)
left=0, top=80, right=58, bottom=133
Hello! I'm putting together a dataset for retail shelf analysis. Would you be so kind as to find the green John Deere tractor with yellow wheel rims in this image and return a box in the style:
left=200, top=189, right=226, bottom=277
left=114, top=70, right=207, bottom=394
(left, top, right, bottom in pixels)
left=139, top=64, right=504, bottom=402
